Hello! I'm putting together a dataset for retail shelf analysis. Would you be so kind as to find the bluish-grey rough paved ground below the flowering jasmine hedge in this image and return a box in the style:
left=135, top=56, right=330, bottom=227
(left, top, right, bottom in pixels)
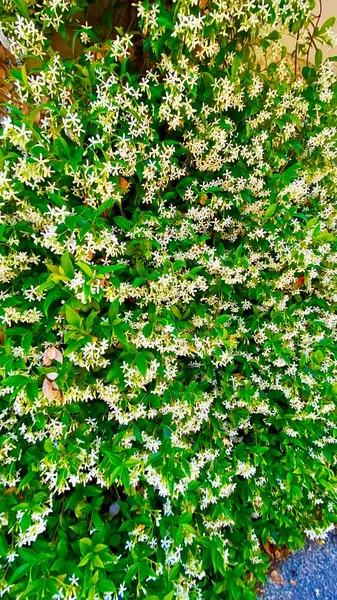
left=262, top=531, right=337, bottom=600
